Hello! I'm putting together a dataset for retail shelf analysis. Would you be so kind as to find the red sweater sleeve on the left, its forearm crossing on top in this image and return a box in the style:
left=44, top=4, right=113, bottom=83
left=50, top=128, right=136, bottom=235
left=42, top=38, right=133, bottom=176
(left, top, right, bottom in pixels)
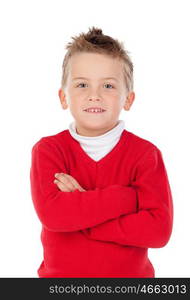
left=30, top=138, right=137, bottom=232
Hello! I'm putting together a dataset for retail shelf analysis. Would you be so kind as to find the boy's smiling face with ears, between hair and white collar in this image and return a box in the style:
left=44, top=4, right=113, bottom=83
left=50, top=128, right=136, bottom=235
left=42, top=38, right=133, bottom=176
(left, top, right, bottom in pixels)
left=59, top=53, right=135, bottom=136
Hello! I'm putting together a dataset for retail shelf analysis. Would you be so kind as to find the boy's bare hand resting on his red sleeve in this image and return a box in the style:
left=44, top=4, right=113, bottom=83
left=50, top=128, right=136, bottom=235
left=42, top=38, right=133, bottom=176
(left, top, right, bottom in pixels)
left=54, top=173, right=86, bottom=192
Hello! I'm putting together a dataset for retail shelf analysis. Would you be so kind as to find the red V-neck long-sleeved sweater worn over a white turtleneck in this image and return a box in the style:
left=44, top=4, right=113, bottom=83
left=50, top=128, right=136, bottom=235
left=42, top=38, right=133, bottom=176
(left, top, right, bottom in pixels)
left=30, top=129, right=173, bottom=278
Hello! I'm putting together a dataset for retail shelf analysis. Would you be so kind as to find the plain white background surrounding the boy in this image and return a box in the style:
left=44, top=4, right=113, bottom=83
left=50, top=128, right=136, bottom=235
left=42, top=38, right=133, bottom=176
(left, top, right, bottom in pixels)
left=0, top=0, right=190, bottom=277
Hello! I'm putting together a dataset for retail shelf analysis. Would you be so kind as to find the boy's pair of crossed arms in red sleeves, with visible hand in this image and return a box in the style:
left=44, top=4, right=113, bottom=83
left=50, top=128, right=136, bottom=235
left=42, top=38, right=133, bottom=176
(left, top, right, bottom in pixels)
left=31, top=138, right=173, bottom=248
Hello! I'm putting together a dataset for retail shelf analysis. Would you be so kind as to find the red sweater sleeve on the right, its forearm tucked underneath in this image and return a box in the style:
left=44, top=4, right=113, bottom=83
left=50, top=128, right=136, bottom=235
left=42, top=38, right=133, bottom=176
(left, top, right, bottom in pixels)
left=84, top=146, right=173, bottom=248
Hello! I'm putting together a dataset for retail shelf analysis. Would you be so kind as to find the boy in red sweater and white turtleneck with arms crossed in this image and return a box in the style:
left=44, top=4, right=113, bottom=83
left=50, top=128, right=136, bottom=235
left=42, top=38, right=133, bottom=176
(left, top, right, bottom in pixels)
left=30, top=27, right=173, bottom=277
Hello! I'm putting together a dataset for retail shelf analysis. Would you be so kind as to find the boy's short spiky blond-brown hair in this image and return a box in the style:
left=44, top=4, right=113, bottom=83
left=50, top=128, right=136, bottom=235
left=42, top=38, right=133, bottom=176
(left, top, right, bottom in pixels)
left=61, top=26, right=133, bottom=92
